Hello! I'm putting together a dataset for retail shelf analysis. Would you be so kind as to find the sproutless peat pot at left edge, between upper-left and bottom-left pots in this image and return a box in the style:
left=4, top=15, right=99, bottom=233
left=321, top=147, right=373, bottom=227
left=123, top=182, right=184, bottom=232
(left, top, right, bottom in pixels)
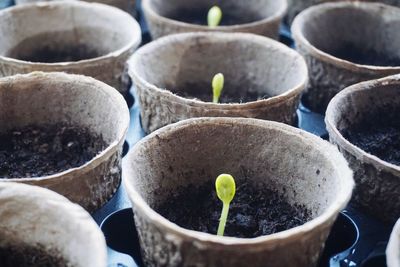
left=0, top=72, right=129, bottom=212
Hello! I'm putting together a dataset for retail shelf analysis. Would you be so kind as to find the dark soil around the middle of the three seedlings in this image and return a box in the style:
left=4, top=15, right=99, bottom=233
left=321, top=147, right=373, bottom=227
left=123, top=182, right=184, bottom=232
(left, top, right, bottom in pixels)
left=173, top=83, right=271, bottom=104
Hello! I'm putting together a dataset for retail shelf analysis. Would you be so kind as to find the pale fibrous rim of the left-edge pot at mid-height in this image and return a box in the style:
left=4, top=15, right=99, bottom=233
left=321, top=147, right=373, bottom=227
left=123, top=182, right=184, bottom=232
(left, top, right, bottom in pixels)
left=0, top=71, right=130, bottom=183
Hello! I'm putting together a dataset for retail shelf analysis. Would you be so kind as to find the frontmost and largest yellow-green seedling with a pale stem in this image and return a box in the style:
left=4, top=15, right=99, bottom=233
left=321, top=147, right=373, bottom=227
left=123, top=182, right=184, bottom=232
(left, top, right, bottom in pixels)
left=215, top=174, right=236, bottom=236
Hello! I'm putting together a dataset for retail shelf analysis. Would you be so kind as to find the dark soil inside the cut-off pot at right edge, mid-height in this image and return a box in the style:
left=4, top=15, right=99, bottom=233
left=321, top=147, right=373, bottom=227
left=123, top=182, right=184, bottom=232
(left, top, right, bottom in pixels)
left=343, top=107, right=400, bottom=166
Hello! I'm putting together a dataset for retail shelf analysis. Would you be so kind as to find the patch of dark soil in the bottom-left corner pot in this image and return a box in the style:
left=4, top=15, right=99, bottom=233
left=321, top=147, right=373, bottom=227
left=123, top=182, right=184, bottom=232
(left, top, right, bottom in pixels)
left=0, top=247, right=70, bottom=267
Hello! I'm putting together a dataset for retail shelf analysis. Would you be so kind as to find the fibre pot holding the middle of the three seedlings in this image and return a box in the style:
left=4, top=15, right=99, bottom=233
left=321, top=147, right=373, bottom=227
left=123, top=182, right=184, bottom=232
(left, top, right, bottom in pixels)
left=129, top=33, right=308, bottom=133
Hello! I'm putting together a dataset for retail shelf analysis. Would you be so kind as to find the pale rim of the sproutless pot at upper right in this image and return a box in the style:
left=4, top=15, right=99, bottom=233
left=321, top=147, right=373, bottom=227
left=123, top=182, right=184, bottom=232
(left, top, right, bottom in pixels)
left=291, top=1, right=400, bottom=73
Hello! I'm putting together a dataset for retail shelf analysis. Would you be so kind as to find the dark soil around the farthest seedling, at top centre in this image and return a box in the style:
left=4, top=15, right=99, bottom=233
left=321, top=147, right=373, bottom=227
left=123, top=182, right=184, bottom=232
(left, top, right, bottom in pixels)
left=169, top=9, right=262, bottom=26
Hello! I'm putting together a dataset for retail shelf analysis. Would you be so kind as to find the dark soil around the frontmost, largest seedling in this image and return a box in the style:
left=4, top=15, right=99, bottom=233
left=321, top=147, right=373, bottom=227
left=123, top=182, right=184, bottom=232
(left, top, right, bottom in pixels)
left=156, top=181, right=311, bottom=238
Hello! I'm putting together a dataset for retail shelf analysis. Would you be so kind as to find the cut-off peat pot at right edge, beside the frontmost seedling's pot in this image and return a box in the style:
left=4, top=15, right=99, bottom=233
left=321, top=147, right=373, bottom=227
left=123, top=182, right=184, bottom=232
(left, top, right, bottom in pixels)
left=325, top=75, right=400, bottom=223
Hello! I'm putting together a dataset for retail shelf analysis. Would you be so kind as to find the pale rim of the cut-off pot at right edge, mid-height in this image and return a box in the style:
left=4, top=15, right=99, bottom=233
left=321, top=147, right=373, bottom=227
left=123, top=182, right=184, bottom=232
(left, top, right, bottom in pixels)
left=325, top=74, right=400, bottom=178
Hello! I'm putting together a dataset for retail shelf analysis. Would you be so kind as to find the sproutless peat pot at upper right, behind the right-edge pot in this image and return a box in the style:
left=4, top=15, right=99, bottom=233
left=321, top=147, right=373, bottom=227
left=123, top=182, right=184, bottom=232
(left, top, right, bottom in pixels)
left=292, top=2, right=400, bottom=113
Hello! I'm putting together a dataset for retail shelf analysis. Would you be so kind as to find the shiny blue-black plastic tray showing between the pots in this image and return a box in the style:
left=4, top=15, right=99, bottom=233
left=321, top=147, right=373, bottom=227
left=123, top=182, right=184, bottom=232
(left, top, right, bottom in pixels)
left=0, top=0, right=392, bottom=267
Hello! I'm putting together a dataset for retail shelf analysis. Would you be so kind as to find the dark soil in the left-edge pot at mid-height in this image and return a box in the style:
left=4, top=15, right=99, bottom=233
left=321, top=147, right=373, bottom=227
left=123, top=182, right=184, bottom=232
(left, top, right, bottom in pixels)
left=0, top=124, right=106, bottom=178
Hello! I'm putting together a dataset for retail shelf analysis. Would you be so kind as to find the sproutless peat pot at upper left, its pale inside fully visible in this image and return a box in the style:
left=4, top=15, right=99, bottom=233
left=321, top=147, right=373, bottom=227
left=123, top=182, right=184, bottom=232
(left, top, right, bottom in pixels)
left=0, top=1, right=141, bottom=93
